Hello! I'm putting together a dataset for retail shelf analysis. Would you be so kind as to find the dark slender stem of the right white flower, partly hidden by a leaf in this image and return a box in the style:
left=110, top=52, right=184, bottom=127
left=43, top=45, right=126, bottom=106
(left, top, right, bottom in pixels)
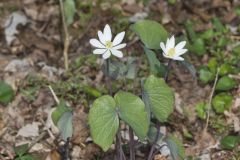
left=148, top=59, right=172, bottom=160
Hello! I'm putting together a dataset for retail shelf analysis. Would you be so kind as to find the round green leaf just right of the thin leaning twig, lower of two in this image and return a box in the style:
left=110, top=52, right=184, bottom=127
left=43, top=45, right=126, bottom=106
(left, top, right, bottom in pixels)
left=212, top=93, right=233, bottom=113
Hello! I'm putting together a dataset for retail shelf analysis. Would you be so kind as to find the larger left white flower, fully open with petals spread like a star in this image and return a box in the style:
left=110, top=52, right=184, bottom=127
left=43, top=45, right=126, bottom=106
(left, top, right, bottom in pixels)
left=90, top=24, right=126, bottom=59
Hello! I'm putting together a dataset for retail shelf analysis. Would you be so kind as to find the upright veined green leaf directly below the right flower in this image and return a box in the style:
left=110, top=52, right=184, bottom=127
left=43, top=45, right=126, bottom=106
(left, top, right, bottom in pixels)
left=144, top=75, right=174, bottom=122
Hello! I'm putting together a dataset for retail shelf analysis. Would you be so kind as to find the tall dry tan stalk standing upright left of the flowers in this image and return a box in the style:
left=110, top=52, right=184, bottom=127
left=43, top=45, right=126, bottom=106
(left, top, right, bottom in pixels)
left=59, top=0, right=70, bottom=70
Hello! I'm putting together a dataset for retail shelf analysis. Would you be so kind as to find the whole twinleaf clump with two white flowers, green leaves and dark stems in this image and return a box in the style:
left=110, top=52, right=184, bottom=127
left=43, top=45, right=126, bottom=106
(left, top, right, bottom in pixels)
left=89, top=20, right=190, bottom=160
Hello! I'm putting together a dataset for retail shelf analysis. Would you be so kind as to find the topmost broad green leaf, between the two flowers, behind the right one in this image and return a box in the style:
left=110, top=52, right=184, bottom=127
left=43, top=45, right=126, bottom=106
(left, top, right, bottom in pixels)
left=131, top=20, right=168, bottom=49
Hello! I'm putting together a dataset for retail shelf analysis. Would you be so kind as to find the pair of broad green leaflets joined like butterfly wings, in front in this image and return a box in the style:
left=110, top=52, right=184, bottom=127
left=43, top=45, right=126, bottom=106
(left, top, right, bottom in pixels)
left=89, top=91, right=149, bottom=151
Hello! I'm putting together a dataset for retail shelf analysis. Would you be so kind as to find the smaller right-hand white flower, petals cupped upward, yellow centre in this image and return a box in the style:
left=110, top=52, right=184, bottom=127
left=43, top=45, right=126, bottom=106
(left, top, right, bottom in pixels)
left=160, top=36, right=187, bottom=61
